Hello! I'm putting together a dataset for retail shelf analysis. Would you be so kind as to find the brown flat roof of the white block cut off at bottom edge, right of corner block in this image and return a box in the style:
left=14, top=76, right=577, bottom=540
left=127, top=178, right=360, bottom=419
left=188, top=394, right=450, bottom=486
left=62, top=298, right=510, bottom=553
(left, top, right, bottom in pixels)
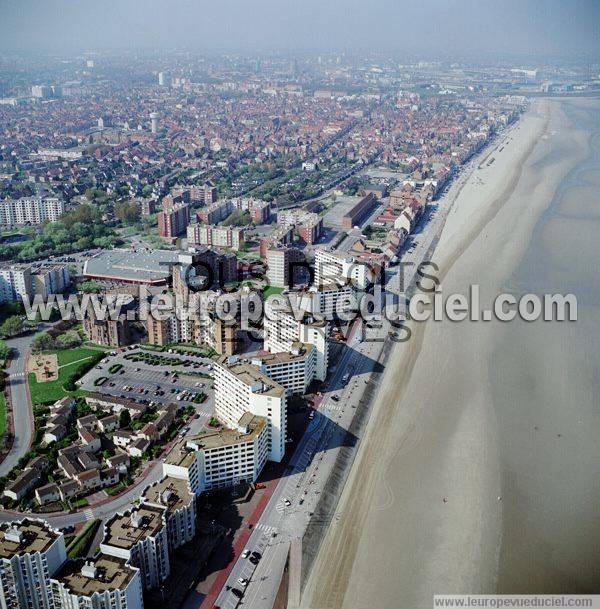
left=55, top=554, right=137, bottom=596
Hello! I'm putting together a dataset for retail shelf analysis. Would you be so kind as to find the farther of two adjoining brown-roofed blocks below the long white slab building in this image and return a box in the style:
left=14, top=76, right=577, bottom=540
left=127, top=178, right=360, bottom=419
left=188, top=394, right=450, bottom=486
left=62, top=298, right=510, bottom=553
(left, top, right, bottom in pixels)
left=142, top=476, right=196, bottom=550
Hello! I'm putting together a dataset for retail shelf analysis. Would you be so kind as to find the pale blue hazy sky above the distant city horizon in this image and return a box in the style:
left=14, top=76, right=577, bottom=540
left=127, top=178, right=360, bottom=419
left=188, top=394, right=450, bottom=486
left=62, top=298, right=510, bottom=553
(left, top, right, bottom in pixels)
left=0, top=0, right=600, bottom=55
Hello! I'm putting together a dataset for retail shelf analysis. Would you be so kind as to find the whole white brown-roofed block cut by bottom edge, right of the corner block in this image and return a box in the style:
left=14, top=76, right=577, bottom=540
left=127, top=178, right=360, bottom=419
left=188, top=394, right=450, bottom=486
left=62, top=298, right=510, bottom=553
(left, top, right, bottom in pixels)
left=50, top=554, right=144, bottom=609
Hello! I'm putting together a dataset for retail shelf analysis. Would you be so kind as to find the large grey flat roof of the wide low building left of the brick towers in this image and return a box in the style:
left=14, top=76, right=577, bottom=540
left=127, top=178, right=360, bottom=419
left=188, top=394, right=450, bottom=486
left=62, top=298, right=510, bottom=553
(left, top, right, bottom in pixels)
left=83, top=249, right=178, bottom=283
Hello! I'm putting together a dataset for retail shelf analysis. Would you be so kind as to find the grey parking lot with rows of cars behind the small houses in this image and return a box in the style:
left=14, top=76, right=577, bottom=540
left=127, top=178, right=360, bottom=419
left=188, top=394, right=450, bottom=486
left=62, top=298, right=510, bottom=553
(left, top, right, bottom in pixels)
left=79, top=347, right=214, bottom=432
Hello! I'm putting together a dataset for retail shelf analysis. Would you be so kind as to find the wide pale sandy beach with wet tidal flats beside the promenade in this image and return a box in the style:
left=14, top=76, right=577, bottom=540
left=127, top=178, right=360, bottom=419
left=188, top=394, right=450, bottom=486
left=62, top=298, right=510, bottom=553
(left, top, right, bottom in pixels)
left=303, top=100, right=600, bottom=609
